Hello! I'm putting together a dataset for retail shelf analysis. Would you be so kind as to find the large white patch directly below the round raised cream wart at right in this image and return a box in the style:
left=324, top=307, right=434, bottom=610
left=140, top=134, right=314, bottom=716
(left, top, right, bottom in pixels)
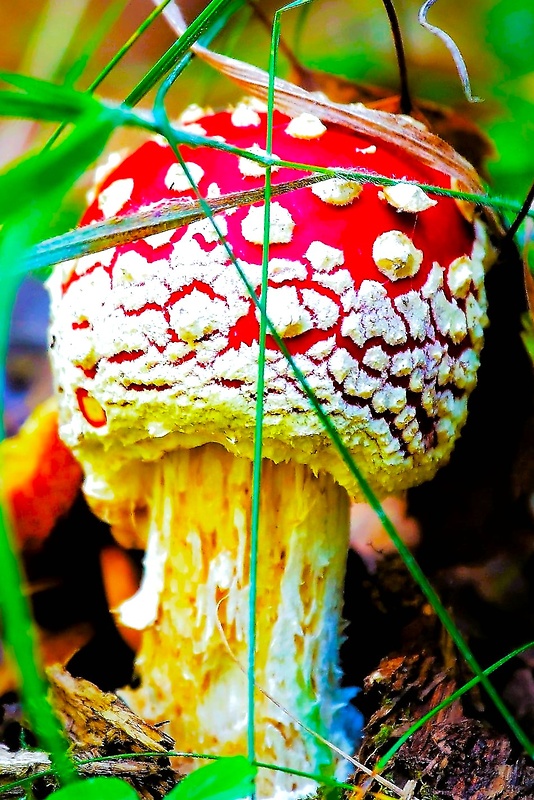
left=341, top=280, right=407, bottom=347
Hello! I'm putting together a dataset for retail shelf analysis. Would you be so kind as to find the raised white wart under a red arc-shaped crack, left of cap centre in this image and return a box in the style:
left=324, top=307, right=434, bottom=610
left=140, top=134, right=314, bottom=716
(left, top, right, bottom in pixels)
left=169, top=289, right=228, bottom=345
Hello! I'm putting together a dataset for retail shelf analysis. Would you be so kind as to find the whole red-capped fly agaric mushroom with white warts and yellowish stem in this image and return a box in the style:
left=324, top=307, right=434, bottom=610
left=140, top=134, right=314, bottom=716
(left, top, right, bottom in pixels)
left=51, top=101, right=496, bottom=797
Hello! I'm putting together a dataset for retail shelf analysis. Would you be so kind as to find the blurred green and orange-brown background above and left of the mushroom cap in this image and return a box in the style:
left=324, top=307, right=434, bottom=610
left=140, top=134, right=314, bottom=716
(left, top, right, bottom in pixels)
left=0, top=0, right=534, bottom=433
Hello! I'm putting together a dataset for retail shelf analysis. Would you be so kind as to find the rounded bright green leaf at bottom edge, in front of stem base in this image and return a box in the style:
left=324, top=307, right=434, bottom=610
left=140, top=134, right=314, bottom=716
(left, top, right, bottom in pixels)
left=166, top=756, right=258, bottom=800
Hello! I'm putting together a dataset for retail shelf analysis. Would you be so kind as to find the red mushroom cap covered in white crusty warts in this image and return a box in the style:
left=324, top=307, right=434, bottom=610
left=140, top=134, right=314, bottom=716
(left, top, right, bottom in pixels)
left=51, top=101, right=491, bottom=497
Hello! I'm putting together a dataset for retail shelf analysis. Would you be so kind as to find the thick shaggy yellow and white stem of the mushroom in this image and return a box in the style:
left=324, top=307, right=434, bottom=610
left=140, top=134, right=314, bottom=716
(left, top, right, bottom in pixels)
left=88, top=444, right=356, bottom=797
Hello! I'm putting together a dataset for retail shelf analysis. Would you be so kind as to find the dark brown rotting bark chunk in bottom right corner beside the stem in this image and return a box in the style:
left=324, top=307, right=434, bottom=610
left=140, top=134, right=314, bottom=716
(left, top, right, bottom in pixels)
left=358, top=559, right=534, bottom=800
